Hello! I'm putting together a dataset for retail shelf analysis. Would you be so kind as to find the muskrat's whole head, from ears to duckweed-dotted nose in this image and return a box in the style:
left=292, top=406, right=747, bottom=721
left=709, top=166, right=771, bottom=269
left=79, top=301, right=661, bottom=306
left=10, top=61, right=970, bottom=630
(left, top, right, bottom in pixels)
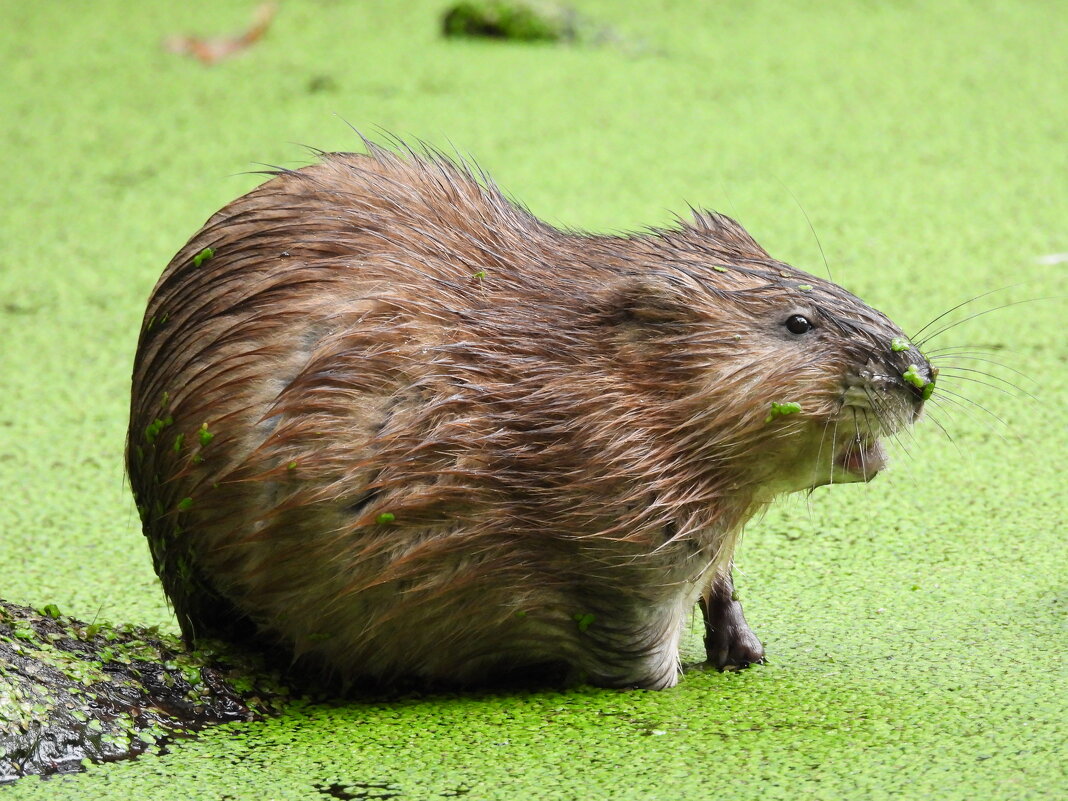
left=606, top=213, right=938, bottom=499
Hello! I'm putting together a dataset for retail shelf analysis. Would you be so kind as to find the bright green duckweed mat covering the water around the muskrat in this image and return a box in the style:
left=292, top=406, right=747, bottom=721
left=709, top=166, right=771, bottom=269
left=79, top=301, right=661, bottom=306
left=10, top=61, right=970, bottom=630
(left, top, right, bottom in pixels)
left=0, top=0, right=1068, bottom=800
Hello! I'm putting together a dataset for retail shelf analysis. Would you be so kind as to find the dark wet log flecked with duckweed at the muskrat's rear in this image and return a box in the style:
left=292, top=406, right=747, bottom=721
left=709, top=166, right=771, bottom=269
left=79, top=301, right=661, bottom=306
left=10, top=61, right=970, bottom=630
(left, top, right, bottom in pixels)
left=0, top=601, right=290, bottom=784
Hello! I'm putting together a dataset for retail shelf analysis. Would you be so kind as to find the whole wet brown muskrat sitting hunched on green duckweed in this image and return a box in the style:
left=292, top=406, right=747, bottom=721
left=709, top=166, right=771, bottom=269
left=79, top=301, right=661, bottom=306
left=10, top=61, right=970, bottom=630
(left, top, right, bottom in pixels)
left=127, top=143, right=936, bottom=689
